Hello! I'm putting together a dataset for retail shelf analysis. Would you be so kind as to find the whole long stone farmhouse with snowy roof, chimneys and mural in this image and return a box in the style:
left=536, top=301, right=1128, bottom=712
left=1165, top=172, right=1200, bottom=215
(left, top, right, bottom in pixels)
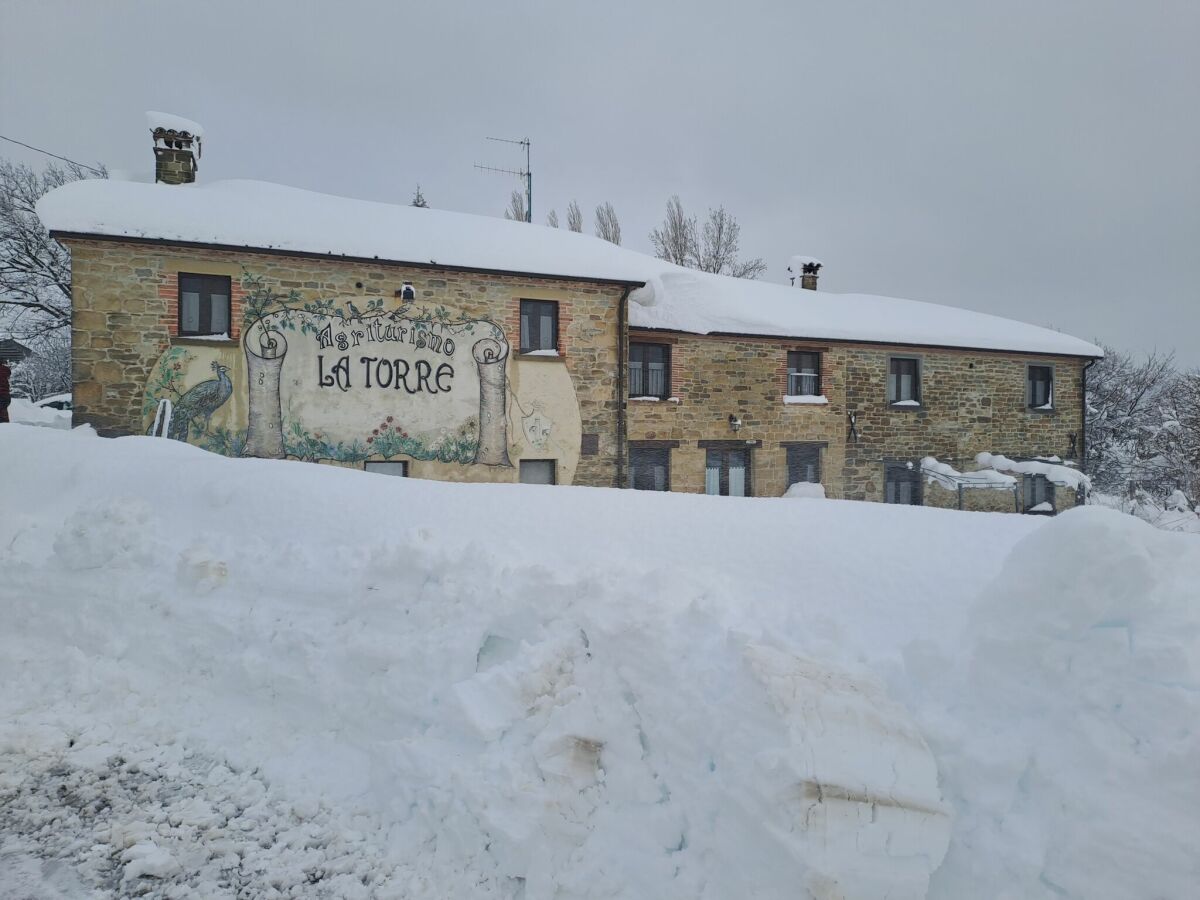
left=38, top=114, right=1102, bottom=512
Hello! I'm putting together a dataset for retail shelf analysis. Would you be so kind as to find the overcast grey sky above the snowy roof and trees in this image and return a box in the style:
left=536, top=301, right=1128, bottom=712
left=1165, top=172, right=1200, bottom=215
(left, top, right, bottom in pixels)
left=0, top=0, right=1200, bottom=366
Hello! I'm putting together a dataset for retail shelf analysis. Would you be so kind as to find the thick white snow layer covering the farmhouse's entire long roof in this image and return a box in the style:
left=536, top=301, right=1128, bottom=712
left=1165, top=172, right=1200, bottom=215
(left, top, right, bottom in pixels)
left=37, top=180, right=1103, bottom=356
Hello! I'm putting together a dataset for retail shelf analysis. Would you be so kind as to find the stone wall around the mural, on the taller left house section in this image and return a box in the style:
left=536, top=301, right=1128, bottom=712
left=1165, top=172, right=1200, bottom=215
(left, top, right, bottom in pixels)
left=70, top=240, right=623, bottom=486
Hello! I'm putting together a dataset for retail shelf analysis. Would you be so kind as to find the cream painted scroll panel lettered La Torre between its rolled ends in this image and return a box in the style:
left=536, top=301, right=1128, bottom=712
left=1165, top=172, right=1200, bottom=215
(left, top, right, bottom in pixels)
left=245, top=310, right=512, bottom=466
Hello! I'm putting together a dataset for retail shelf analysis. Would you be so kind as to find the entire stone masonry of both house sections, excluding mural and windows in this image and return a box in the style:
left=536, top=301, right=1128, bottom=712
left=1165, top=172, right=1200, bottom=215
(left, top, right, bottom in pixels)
left=68, top=239, right=1087, bottom=510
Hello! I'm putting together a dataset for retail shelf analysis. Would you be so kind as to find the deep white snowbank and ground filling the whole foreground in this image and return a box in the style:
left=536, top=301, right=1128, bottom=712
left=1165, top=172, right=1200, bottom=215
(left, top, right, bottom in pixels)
left=0, top=426, right=1200, bottom=900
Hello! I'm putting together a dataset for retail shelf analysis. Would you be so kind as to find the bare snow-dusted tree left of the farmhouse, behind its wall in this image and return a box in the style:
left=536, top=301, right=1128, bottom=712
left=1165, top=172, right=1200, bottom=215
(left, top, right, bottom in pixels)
left=0, top=160, right=107, bottom=340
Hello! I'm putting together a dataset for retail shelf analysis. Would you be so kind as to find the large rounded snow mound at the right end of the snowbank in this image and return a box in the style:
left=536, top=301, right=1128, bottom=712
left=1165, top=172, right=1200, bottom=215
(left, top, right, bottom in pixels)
left=906, top=508, right=1200, bottom=900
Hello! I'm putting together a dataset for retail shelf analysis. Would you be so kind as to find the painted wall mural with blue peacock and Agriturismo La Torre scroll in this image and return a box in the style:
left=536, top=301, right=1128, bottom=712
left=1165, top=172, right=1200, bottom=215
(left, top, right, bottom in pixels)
left=144, top=272, right=512, bottom=467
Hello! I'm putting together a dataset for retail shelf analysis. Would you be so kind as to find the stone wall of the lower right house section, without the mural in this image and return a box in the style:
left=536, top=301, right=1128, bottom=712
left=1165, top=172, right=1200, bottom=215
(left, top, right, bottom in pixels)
left=628, top=330, right=1086, bottom=511
